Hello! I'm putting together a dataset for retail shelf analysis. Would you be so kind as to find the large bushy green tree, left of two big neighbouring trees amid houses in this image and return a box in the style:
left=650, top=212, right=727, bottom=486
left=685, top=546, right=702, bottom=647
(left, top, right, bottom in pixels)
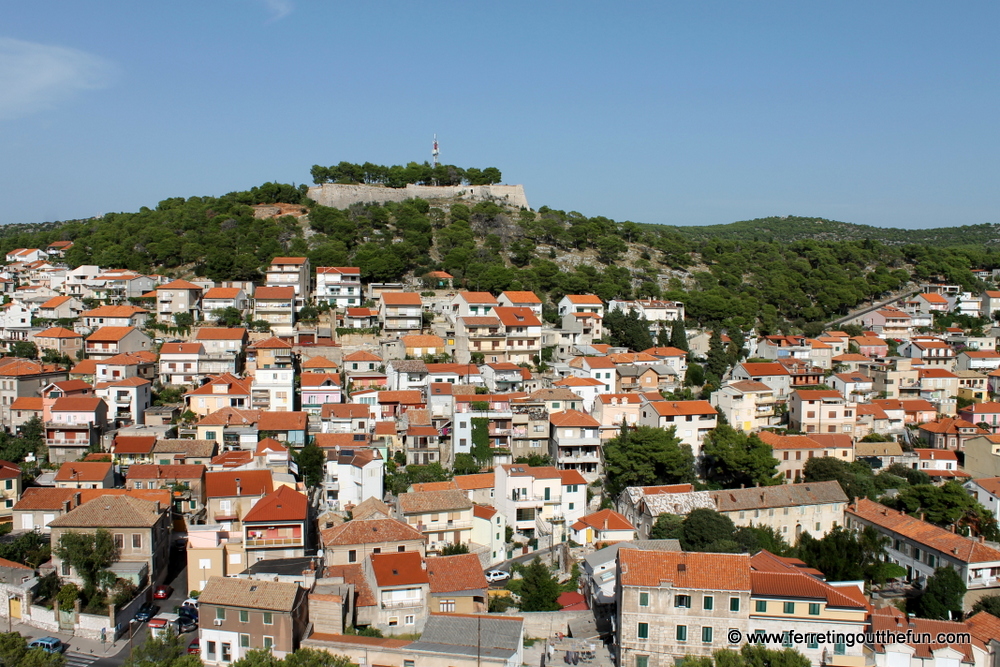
left=604, top=425, right=695, bottom=498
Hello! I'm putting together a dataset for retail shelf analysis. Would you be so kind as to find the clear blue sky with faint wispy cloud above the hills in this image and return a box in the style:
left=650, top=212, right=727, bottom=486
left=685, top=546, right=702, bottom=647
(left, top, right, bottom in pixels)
left=0, top=0, right=1000, bottom=227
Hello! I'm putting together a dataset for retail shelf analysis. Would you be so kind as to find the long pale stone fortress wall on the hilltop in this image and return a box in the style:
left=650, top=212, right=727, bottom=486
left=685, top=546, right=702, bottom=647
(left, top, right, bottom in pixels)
left=308, top=183, right=531, bottom=209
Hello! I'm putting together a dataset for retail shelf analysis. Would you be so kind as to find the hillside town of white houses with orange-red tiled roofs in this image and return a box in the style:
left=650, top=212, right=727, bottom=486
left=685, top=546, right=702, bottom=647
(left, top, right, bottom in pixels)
left=0, top=247, right=1000, bottom=667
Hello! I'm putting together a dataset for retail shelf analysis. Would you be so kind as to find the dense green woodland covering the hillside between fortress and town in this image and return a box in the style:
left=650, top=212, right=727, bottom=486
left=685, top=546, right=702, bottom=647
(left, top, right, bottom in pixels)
left=0, top=183, right=1000, bottom=333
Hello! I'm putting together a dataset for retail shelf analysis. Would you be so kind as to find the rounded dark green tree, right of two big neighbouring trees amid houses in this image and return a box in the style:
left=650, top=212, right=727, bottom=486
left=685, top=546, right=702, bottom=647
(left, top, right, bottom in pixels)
left=701, top=425, right=782, bottom=489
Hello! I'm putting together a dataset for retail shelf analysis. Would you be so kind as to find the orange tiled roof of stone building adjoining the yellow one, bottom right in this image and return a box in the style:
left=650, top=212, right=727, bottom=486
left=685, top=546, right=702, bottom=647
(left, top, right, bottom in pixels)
left=618, top=549, right=750, bottom=591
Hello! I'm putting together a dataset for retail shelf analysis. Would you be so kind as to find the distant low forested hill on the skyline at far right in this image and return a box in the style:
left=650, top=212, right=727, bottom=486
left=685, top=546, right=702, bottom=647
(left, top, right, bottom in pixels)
left=656, top=216, right=1000, bottom=248
